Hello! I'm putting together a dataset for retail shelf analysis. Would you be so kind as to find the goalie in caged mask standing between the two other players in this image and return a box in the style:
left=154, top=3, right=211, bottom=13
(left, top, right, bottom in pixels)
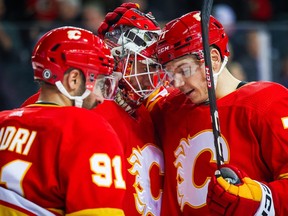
left=95, top=3, right=164, bottom=216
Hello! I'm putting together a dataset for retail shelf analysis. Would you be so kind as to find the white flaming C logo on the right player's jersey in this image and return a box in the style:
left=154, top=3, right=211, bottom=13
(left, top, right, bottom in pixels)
left=174, top=131, right=228, bottom=211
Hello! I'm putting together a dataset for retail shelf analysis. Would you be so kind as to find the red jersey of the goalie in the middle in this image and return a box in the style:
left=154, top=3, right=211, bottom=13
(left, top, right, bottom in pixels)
left=94, top=101, right=164, bottom=216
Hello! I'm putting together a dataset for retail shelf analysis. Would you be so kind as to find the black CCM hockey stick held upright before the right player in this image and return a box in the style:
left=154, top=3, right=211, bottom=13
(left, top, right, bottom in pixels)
left=201, top=0, right=224, bottom=170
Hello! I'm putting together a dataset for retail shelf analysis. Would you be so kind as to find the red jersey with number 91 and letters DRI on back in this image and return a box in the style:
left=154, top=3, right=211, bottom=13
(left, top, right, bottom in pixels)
left=0, top=104, right=126, bottom=215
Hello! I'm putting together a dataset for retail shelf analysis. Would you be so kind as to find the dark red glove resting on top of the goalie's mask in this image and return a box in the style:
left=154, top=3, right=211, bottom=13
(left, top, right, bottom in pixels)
left=98, top=2, right=140, bottom=39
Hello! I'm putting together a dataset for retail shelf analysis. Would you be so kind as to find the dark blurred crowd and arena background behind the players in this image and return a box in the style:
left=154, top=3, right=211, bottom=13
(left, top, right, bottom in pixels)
left=0, top=0, right=288, bottom=110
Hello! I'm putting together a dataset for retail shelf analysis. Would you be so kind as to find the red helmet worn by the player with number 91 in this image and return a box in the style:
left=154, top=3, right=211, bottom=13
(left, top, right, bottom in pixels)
left=32, top=26, right=114, bottom=90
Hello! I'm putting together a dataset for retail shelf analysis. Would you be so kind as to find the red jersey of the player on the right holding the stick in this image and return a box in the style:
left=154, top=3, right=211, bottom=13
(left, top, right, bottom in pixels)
left=151, top=82, right=288, bottom=216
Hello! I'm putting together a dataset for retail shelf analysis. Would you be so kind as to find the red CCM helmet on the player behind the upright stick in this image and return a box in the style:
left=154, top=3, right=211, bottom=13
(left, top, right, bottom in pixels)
left=156, top=11, right=230, bottom=64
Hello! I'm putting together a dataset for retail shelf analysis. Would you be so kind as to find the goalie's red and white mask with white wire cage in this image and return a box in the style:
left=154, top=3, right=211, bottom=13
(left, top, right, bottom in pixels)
left=105, top=8, right=164, bottom=111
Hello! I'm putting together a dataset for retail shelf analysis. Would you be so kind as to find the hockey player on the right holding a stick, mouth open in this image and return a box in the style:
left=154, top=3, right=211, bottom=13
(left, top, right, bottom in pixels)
left=151, top=11, right=288, bottom=216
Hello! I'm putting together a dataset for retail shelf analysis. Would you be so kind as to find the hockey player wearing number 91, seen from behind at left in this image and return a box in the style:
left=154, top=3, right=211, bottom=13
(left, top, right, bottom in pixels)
left=0, top=27, right=126, bottom=215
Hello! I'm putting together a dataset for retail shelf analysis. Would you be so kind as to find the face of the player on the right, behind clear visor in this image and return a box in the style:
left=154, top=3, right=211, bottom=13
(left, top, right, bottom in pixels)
left=165, top=55, right=208, bottom=104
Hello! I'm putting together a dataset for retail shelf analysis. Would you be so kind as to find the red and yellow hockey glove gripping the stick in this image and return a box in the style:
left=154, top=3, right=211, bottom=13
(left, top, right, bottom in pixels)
left=207, top=165, right=275, bottom=216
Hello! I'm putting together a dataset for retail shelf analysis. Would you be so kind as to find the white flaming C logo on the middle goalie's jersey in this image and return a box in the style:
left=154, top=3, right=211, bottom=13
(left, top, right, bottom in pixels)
left=128, top=145, right=164, bottom=216
